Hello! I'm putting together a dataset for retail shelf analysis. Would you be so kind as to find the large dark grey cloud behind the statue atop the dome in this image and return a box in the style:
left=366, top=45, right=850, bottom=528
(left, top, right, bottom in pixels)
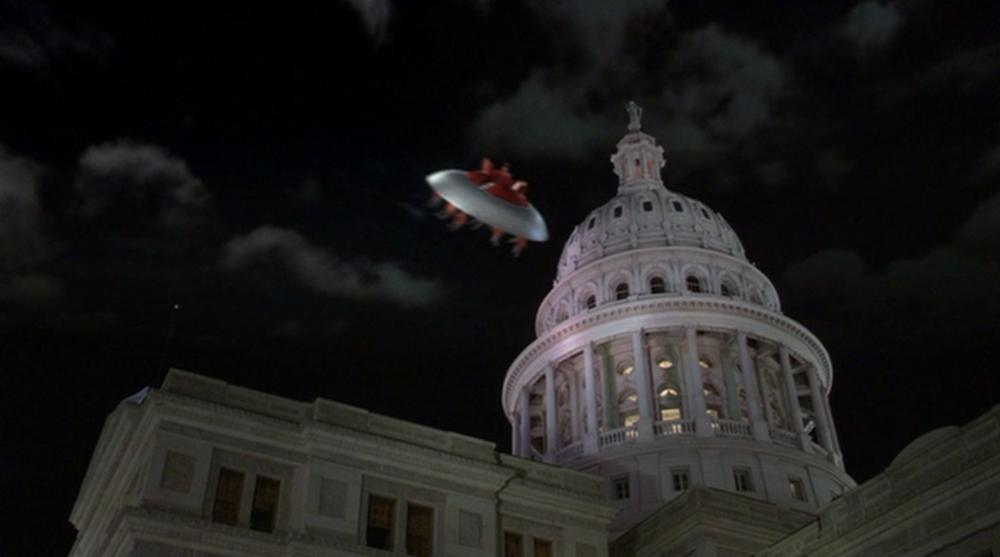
left=471, top=15, right=790, bottom=177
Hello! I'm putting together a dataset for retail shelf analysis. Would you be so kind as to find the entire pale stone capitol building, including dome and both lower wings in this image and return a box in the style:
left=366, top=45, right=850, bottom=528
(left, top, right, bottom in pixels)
left=70, top=103, right=1000, bottom=557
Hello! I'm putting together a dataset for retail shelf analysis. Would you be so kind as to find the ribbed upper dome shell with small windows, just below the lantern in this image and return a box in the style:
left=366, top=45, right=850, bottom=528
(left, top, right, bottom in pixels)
left=556, top=183, right=745, bottom=283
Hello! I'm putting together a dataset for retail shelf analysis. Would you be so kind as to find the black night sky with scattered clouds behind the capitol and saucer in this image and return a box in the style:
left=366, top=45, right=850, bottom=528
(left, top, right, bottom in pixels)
left=0, top=0, right=1000, bottom=556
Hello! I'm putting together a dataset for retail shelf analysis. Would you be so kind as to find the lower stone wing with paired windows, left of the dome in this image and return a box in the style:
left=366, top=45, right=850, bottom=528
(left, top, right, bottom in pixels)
left=70, top=370, right=614, bottom=557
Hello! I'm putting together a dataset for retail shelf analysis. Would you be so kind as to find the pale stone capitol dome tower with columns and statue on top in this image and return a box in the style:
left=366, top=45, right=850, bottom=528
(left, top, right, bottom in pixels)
left=502, top=103, right=854, bottom=535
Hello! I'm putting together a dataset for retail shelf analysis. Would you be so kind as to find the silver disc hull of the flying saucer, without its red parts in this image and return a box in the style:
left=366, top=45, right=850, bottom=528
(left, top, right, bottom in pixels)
left=427, top=170, right=549, bottom=242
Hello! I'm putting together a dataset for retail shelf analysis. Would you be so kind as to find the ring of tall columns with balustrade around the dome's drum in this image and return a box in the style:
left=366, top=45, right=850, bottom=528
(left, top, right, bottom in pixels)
left=512, top=325, right=841, bottom=466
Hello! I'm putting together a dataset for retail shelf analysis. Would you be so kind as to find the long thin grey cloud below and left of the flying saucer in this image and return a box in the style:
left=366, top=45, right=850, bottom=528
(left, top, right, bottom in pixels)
left=222, top=226, right=442, bottom=307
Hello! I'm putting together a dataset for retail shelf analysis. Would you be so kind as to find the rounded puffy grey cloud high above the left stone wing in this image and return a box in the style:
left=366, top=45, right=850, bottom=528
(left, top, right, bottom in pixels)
left=76, top=140, right=211, bottom=229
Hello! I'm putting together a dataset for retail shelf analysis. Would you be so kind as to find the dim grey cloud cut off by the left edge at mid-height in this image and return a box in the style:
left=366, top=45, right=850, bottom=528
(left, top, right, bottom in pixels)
left=0, top=145, right=52, bottom=269
